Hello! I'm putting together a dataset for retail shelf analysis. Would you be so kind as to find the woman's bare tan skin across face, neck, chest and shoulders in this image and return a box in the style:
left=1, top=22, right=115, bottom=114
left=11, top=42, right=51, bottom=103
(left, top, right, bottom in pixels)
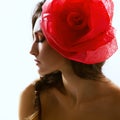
left=19, top=31, right=120, bottom=120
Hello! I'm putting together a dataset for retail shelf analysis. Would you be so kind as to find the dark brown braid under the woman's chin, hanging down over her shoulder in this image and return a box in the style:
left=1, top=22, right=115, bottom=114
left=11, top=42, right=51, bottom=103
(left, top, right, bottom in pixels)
left=34, top=71, right=64, bottom=119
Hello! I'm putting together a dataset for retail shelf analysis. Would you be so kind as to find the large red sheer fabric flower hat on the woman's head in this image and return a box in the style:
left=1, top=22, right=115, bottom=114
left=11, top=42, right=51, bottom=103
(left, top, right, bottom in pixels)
left=40, top=0, right=117, bottom=64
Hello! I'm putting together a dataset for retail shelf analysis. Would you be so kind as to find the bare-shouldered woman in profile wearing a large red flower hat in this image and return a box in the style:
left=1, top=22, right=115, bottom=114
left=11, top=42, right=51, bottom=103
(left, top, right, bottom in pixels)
left=19, top=0, right=120, bottom=120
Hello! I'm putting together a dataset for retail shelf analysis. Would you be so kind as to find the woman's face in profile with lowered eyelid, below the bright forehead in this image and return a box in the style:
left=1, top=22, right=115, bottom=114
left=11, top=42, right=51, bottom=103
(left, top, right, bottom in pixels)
left=30, top=31, right=66, bottom=76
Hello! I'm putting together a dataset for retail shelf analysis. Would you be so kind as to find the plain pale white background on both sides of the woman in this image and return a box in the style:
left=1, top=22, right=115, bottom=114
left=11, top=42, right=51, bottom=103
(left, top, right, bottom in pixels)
left=0, top=0, right=120, bottom=120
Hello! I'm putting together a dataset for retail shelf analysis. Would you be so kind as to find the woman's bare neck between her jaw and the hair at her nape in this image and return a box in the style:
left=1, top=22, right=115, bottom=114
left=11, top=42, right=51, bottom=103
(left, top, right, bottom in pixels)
left=62, top=63, right=108, bottom=104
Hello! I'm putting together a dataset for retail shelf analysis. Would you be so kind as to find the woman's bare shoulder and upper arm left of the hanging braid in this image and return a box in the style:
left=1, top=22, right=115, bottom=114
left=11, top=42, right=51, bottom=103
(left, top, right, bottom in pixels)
left=19, top=83, right=35, bottom=120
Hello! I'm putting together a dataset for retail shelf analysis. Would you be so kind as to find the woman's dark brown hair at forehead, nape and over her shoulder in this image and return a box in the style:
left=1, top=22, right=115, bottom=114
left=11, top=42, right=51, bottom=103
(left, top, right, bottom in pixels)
left=32, top=0, right=104, bottom=117
